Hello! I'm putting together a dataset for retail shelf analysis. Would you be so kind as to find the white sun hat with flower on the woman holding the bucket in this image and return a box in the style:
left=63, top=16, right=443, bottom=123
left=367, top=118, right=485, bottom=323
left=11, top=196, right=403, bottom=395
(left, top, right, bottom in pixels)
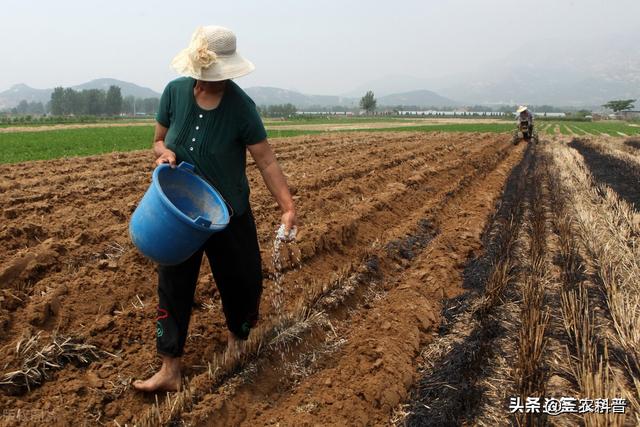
left=171, top=25, right=256, bottom=82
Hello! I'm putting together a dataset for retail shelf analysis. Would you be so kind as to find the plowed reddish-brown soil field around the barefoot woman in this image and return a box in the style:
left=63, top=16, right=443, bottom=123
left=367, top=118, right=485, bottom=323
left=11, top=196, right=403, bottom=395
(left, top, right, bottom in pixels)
left=0, top=133, right=527, bottom=425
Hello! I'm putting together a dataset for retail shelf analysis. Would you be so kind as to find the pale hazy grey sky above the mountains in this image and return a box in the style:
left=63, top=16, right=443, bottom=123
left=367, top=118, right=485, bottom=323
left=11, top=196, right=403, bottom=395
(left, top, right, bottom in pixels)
left=0, top=0, right=640, bottom=94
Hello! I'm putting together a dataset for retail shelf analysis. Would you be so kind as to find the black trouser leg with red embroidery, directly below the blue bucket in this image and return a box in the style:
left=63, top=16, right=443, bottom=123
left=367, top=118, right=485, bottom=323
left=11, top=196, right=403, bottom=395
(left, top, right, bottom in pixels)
left=156, top=249, right=204, bottom=357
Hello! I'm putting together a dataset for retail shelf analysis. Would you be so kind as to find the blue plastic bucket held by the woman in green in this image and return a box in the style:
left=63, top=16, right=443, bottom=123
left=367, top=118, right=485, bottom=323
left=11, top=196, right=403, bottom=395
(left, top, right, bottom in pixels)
left=129, top=162, right=229, bottom=265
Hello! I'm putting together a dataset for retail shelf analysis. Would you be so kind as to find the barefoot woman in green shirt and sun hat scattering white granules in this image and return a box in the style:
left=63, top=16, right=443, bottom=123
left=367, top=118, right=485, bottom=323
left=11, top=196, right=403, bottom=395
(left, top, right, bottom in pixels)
left=133, top=26, right=296, bottom=391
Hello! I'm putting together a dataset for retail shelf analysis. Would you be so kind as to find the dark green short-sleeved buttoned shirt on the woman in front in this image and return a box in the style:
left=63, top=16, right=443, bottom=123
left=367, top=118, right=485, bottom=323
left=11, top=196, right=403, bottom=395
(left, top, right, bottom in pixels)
left=156, top=77, right=267, bottom=215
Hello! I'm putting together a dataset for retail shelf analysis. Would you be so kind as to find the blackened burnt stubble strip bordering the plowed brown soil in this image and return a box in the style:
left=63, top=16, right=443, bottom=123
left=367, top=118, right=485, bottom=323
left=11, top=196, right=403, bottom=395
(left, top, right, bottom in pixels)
left=406, top=143, right=533, bottom=426
